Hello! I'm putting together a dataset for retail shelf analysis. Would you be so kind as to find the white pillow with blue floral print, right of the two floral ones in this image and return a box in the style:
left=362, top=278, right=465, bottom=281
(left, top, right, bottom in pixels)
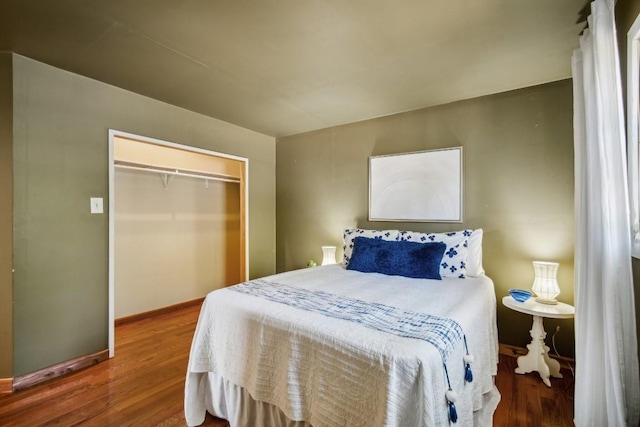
left=398, top=230, right=473, bottom=279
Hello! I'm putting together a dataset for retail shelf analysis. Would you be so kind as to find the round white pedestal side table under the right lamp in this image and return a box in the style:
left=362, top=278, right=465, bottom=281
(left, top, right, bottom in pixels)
left=502, top=295, right=575, bottom=387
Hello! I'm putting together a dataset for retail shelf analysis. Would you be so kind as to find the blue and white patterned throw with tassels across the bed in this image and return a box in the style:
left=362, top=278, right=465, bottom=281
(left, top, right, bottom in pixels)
left=227, top=279, right=472, bottom=422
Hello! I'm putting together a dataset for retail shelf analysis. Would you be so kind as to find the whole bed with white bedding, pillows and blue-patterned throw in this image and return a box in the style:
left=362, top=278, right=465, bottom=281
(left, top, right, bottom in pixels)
left=185, top=229, right=500, bottom=427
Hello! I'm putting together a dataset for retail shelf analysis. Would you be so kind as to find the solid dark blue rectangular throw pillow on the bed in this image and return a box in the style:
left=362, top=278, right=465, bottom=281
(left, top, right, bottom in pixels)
left=347, top=237, right=447, bottom=280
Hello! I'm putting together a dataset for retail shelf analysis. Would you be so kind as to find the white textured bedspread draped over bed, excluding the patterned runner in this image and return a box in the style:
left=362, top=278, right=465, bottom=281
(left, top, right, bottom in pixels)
left=185, top=265, right=498, bottom=427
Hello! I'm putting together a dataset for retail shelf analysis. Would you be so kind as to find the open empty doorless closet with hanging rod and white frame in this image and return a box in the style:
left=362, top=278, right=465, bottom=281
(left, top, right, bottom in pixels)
left=109, top=130, right=248, bottom=357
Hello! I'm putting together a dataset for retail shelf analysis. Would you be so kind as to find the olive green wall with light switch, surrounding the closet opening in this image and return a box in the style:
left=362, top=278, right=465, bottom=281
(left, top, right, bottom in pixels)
left=10, top=55, right=275, bottom=376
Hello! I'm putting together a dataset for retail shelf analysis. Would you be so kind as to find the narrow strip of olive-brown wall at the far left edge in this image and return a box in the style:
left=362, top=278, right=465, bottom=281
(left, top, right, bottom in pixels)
left=0, top=52, right=13, bottom=378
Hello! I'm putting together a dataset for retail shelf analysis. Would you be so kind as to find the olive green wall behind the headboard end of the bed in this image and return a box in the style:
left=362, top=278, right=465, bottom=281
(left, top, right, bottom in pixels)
left=276, top=80, right=574, bottom=356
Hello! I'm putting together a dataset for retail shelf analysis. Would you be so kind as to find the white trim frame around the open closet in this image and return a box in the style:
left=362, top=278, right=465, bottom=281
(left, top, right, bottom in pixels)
left=108, top=129, right=249, bottom=358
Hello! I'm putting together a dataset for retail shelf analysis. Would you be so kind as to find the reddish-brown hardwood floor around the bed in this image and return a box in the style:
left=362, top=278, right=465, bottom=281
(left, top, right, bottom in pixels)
left=0, top=307, right=573, bottom=427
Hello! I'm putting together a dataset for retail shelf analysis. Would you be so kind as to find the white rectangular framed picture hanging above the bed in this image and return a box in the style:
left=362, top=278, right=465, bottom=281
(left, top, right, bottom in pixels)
left=369, top=147, right=462, bottom=222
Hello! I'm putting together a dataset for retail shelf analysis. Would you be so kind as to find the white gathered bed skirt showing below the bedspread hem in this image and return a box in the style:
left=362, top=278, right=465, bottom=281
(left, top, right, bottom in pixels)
left=189, top=372, right=500, bottom=427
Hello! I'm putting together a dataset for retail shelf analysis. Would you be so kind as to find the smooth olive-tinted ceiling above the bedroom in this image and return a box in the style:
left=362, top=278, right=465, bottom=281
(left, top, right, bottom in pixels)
left=0, top=0, right=585, bottom=136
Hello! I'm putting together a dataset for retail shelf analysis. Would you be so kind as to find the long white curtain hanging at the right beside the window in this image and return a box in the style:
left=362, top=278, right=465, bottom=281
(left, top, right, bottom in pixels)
left=572, top=0, right=640, bottom=427
